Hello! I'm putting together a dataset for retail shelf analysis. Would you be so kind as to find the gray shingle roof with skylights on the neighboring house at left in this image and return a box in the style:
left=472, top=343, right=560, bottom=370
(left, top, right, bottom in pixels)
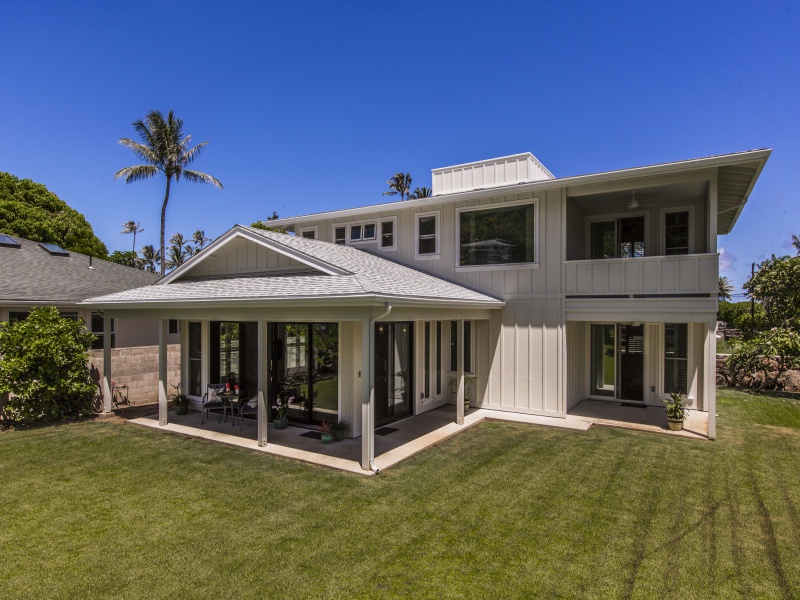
left=0, top=236, right=160, bottom=306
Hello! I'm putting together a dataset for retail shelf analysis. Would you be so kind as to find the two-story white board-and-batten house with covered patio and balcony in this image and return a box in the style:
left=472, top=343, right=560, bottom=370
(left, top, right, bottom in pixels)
left=87, top=150, right=770, bottom=468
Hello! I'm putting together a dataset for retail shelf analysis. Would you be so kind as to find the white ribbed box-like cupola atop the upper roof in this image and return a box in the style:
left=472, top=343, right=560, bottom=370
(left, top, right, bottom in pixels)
left=431, top=152, right=555, bottom=196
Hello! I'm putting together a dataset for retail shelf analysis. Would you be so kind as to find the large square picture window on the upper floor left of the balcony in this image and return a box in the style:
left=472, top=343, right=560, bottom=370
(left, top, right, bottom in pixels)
left=458, top=202, right=536, bottom=267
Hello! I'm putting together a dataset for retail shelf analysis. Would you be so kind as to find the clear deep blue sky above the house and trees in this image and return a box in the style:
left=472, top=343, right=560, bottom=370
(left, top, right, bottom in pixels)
left=0, top=1, right=800, bottom=296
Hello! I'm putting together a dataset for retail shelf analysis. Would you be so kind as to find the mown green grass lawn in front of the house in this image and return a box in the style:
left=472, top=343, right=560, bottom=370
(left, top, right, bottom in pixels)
left=0, top=392, right=800, bottom=599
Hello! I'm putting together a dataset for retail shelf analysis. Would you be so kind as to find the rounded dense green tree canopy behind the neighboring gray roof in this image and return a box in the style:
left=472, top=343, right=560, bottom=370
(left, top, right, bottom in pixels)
left=0, top=172, right=108, bottom=258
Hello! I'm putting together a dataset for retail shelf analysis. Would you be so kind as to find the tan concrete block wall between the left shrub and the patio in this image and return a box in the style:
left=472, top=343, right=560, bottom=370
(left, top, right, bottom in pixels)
left=89, top=344, right=181, bottom=404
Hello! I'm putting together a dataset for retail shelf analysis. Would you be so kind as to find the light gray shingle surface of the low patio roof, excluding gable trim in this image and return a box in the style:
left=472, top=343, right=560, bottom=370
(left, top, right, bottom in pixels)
left=81, top=225, right=503, bottom=306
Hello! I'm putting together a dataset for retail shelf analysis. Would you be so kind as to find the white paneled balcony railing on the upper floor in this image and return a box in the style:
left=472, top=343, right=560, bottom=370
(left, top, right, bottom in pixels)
left=563, top=254, right=719, bottom=295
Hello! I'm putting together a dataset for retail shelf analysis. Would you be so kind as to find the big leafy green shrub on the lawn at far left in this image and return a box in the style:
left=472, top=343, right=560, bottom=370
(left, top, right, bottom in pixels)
left=0, top=306, right=97, bottom=423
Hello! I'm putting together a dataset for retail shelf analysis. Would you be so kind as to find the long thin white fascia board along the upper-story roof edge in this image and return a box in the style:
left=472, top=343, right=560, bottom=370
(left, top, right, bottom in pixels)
left=270, top=149, right=772, bottom=228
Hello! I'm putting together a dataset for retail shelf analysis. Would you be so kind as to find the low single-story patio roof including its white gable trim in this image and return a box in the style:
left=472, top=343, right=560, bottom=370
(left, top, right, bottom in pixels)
left=81, top=225, right=505, bottom=308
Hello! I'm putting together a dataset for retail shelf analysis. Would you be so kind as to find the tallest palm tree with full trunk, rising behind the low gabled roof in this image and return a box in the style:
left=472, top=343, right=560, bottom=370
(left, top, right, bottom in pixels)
left=114, top=110, right=222, bottom=275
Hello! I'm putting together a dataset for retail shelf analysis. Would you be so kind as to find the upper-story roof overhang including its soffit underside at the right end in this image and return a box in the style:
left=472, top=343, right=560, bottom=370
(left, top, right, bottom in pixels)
left=268, top=149, right=772, bottom=235
